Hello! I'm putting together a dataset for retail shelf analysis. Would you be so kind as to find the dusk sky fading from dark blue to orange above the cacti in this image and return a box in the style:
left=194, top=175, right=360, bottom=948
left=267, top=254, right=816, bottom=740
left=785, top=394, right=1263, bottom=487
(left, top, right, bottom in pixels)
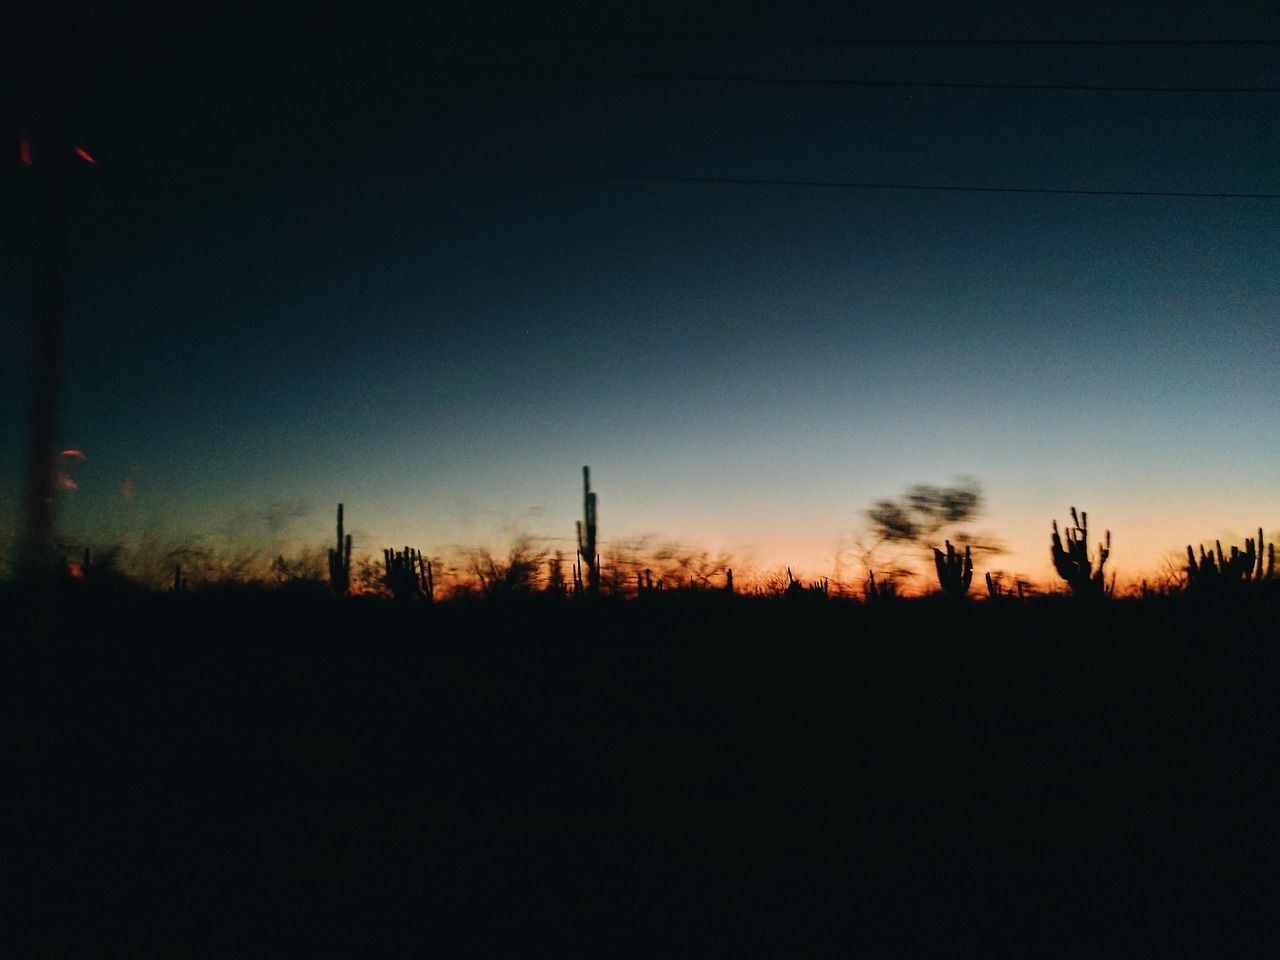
left=0, top=4, right=1280, bottom=591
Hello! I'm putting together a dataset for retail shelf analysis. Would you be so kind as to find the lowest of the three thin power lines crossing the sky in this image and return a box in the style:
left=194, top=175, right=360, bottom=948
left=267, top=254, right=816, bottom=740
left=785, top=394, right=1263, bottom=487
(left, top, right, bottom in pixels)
left=426, top=164, right=1280, bottom=200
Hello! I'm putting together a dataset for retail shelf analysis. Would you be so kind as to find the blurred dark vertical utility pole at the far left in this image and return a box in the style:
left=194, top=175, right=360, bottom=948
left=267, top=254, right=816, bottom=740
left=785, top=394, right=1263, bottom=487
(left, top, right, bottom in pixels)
left=18, top=122, right=72, bottom=577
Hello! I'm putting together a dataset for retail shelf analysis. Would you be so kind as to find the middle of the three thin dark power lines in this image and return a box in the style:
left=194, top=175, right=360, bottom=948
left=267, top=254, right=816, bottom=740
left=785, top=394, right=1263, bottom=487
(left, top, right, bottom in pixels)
left=453, top=64, right=1280, bottom=93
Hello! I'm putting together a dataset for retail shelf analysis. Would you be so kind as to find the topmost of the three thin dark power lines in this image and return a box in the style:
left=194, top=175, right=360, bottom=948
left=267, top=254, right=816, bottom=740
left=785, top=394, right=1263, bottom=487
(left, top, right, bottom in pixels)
left=465, top=27, right=1280, bottom=47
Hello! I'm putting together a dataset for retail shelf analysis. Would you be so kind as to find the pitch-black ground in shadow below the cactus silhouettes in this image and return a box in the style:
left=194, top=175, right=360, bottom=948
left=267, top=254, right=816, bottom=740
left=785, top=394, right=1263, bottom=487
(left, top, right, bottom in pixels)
left=10, top=596, right=1280, bottom=957
